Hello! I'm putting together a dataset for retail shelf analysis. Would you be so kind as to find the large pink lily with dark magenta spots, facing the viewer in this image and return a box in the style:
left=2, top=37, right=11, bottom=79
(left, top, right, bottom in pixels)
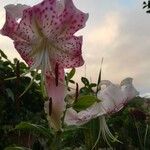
left=1, top=0, right=88, bottom=129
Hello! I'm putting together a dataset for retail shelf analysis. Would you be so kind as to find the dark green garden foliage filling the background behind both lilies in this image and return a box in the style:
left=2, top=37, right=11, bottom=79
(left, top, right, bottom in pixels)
left=0, top=50, right=150, bottom=150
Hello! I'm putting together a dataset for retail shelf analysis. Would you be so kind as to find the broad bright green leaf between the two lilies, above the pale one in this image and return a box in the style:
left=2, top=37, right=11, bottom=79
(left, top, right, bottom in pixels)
left=73, top=95, right=99, bottom=111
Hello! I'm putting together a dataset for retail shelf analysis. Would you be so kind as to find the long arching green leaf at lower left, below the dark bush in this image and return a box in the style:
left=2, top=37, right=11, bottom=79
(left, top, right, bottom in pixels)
left=15, top=122, right=52, bottom=138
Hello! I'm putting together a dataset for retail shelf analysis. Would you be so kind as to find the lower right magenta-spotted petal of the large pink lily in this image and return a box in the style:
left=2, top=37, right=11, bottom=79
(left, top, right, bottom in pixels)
left=55, top=36, right=84, bottom=68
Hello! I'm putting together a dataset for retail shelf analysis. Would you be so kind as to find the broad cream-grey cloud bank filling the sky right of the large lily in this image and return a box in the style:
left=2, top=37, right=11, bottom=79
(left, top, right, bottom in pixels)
left=74, top=9, right=150, bottom=93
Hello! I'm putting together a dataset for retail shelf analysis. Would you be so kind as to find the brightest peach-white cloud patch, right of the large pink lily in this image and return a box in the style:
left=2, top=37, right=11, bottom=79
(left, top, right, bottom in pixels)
left=86, top=12, right=120, bottom=48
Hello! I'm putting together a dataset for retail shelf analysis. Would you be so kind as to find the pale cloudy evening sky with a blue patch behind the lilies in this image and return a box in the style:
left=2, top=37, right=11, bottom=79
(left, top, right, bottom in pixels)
left=0, top=0, right=150, bottom=94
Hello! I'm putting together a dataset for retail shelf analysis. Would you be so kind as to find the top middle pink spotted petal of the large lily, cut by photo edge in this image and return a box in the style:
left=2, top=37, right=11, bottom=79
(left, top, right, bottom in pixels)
left=33, top=0, right=63, bottom=41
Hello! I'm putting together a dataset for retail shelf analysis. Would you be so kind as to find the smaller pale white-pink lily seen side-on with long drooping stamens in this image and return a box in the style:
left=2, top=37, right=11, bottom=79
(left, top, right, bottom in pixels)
left=65, top=78, right=139, bottom=147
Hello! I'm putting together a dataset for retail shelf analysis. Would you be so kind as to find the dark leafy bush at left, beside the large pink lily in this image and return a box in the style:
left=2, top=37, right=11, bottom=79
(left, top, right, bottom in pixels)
left=0, top=50, right=46, bottom=149
